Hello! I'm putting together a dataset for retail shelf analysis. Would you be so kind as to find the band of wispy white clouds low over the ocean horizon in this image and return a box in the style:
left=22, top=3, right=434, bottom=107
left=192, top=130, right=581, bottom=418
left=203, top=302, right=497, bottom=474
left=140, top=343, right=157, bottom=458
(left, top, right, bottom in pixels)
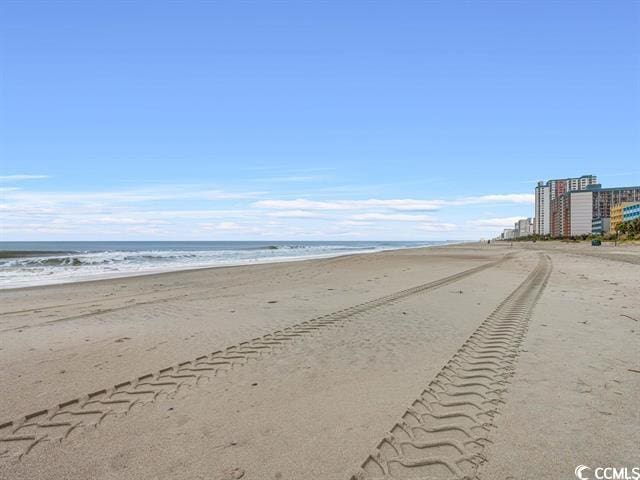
left=0, top=174, right=533, bottom=241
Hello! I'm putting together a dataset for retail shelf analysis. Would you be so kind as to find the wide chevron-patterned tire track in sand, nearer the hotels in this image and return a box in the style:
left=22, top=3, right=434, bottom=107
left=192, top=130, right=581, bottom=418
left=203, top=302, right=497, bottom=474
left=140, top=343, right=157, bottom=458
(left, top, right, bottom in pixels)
left=351, top=255, right=552, bottom=480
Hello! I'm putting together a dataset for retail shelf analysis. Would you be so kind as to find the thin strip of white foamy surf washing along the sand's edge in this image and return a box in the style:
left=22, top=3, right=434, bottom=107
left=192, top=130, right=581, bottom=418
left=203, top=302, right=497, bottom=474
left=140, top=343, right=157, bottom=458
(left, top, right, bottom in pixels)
left=0, top=240, right=473, bottom=292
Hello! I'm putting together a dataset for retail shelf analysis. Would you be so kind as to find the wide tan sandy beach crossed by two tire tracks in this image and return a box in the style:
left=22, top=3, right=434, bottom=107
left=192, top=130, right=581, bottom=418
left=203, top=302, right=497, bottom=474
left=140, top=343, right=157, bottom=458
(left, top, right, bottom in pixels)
left=0, top=246, right=640, bottom=480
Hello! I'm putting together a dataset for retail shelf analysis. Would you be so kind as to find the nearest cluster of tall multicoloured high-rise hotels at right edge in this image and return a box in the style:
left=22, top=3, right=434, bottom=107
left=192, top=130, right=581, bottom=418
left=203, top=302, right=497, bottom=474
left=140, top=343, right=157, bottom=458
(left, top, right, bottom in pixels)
left=533, top=175, right=640, bottom=237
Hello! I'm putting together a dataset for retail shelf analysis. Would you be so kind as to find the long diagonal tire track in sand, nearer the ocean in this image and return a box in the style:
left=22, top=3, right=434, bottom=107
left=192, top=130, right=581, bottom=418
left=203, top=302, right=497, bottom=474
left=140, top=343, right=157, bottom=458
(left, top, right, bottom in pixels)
left=0, top=254, right=513, bottom=460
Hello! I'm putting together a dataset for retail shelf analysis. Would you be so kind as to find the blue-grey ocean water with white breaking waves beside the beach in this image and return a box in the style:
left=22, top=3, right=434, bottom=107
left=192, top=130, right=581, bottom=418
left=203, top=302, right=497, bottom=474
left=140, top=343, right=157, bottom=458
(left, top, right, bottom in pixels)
left=0, top=241, right=447, bottom=288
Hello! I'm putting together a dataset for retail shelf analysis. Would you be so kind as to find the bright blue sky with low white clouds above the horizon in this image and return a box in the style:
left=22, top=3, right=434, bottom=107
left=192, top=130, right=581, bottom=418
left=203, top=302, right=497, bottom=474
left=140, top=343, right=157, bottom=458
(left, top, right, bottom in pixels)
left=0, top=0, right=640, bottom=240
